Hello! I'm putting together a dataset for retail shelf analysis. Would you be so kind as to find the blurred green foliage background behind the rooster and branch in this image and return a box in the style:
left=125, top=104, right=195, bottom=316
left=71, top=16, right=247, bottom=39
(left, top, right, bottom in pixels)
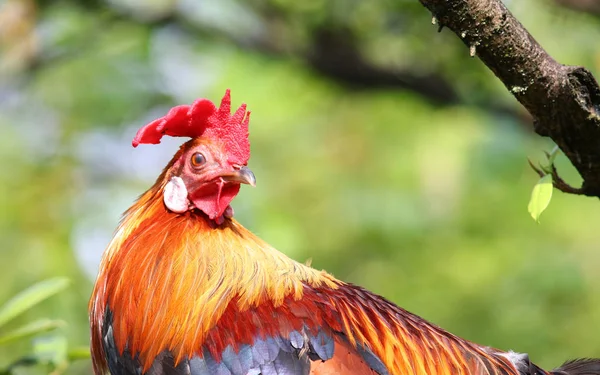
left=0, top=0, right=600, bottom=374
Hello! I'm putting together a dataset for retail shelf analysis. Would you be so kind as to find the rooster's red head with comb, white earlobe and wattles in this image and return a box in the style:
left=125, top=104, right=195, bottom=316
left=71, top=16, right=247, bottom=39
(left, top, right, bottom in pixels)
left=133, top=90, right=256, bottom=222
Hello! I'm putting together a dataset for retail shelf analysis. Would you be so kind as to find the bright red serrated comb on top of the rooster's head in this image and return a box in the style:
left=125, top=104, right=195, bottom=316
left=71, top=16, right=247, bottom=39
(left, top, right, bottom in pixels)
left=132, top=89, right=250, bottom=165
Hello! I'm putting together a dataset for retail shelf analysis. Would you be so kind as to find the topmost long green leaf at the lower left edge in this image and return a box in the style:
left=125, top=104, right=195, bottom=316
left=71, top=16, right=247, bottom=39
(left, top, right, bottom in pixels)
left=0, top=277, right=69, bottom=327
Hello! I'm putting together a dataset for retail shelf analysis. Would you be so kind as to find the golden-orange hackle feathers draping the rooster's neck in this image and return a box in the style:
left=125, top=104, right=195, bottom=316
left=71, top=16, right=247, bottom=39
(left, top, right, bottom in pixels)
left=90, top=174, right=336, bottom=369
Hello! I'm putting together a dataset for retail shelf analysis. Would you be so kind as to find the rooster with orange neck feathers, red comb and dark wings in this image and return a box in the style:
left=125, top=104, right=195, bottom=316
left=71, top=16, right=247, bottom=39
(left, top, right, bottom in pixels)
left=89, top=90, right=600, bottom=375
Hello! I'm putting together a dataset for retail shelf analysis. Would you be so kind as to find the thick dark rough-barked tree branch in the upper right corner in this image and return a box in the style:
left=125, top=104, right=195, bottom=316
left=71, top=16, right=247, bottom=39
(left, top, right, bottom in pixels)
left=420, top=0, right=600, bottom=197
